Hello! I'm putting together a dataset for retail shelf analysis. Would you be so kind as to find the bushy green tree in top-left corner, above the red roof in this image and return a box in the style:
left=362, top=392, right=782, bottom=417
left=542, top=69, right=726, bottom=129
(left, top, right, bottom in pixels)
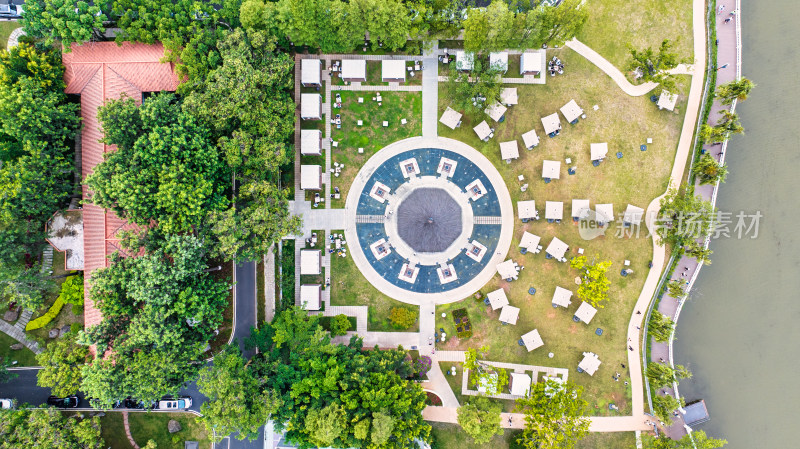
left=21, top=0, right=108, bottom=46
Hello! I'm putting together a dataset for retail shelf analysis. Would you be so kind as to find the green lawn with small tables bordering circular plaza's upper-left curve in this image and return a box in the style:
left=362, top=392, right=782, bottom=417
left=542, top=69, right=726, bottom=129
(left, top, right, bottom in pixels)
left=331, top=91, right=422, bottom=208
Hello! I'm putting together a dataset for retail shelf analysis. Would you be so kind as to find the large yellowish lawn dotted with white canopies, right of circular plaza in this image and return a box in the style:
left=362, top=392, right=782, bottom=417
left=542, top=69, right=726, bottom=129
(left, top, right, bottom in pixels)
left=436, top=49, right=685, bottom=416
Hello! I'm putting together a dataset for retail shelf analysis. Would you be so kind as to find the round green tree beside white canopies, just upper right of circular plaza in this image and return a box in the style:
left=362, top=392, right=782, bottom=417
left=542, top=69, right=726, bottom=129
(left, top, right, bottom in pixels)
left=444, top=57, right=502, bottom=117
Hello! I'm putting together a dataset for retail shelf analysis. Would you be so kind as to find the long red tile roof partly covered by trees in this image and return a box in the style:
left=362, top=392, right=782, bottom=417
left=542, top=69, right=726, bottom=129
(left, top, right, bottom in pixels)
left=62, top=42, right=179, bottom=327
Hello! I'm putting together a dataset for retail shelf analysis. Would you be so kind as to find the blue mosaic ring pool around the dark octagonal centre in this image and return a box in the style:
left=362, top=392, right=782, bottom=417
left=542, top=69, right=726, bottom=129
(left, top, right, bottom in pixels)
left=356, top=148, right=501, bottom=293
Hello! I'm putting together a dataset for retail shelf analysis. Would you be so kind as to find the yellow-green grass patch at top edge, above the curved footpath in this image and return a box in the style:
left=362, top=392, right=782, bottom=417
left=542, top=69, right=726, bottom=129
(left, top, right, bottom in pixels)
left=566, top=0, right=693, bottom=72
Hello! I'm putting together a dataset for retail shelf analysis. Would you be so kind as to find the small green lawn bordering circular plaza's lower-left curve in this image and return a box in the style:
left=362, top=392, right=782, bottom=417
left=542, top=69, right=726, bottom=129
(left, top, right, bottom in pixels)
left=331, top=236, right=419, bottom=332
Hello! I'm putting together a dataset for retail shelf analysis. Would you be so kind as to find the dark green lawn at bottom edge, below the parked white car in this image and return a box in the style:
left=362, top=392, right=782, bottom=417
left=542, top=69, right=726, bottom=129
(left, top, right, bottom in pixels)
left=100, top=412, right=211, bottom=449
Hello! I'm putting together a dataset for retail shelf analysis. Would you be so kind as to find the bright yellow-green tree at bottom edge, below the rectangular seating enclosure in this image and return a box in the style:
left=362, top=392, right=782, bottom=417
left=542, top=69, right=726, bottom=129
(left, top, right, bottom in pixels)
left=517, top=380, right=589, bottom=449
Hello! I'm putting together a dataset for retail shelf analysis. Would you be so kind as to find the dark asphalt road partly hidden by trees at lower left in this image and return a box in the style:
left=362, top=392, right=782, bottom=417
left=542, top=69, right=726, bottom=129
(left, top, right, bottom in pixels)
left=0, top=262, right=264, bottom=449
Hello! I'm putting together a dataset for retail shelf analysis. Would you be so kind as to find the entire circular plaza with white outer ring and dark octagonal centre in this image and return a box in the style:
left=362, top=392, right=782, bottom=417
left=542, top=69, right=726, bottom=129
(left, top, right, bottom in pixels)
left=345, top=137, right=513, bottom=305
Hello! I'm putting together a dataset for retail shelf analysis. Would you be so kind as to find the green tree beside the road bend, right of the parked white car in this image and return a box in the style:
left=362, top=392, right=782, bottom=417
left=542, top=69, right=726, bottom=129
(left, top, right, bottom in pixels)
left=197, top=345, right=279, bottom=440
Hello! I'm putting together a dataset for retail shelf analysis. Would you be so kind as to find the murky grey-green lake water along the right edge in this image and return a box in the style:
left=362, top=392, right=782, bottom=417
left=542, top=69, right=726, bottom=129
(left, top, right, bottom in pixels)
left=675, top=0, right=800, bottom=449
